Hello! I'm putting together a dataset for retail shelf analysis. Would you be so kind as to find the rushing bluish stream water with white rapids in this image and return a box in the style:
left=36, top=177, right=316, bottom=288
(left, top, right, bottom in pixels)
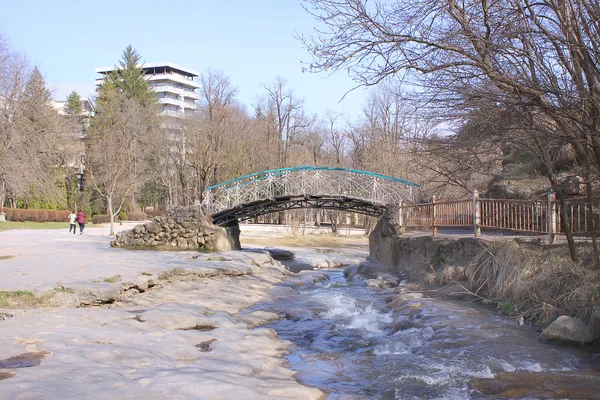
left=255, top=270, right=600, bottom=399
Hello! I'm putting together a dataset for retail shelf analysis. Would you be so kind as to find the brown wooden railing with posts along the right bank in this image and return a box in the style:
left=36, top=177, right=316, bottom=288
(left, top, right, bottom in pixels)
left=398, top=191, right=600, bottom=242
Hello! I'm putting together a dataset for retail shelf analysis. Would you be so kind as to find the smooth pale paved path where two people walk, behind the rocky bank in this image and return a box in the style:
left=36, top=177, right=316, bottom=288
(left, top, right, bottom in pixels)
left=0, top=223, right=196, bottom=291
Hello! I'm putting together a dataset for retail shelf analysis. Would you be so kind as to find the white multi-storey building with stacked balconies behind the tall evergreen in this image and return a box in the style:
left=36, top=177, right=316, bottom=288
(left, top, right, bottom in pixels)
left=96, top=62, right=200, bottom=116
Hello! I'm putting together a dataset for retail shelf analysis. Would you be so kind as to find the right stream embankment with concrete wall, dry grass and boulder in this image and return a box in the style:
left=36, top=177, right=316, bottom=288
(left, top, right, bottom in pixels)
left=364, top=218, right=600, bottom=343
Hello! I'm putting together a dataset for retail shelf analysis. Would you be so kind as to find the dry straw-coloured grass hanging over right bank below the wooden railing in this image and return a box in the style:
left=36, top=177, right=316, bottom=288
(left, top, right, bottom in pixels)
left=440, top=240, right=600, bottom=332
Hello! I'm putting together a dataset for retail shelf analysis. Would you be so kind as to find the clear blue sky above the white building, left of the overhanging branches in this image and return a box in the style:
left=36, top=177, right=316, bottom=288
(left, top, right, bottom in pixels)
left=0, top=0, right=366, bottom=119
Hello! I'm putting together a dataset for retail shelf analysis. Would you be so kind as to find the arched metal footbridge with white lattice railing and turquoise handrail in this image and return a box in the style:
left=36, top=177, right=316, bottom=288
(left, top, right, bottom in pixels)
left=202, top=166, right=419, bottom=226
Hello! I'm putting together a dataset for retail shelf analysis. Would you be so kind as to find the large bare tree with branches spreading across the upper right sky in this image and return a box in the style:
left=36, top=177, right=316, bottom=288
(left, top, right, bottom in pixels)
left=303, top=0, right=600, bottom=267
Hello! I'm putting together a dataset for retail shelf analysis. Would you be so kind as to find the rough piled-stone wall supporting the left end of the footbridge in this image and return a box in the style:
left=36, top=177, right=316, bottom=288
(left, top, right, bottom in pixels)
left=110, top=207, right=241, bottom=251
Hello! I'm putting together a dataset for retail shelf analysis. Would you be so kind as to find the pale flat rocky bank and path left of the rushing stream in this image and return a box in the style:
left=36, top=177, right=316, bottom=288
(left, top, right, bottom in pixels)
left=0, top=228, right=366, bottom=399
